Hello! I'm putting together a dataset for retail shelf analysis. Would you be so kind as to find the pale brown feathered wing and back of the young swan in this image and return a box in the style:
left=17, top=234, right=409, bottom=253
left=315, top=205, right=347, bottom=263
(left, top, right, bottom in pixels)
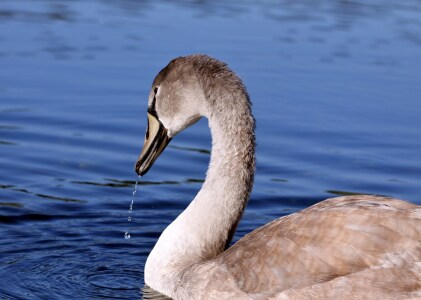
left=215, top=196, right=421, bottom=299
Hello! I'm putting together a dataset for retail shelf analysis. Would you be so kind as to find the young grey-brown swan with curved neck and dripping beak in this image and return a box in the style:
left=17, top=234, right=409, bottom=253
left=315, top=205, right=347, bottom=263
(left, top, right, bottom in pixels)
left=135, top=55, right=421, bottom=299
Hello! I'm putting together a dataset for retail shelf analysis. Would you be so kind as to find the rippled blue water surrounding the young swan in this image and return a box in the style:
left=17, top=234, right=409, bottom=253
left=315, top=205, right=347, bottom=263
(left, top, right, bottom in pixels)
left=0, top=0, right=421, bottom=299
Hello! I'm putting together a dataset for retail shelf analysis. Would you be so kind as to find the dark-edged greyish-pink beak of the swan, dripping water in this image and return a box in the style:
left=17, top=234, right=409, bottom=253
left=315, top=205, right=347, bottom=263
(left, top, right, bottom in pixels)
left=135, top=112, right=171, bottom=176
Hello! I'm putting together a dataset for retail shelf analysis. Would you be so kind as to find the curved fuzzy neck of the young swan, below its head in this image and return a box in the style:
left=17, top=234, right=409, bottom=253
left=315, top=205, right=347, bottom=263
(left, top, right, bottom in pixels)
left=145, top=80, right=255, bottom=291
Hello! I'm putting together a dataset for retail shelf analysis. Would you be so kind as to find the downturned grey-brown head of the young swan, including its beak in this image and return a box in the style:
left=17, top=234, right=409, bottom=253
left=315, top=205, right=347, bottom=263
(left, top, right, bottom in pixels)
left=135, top=55, right=205, bottom=176
